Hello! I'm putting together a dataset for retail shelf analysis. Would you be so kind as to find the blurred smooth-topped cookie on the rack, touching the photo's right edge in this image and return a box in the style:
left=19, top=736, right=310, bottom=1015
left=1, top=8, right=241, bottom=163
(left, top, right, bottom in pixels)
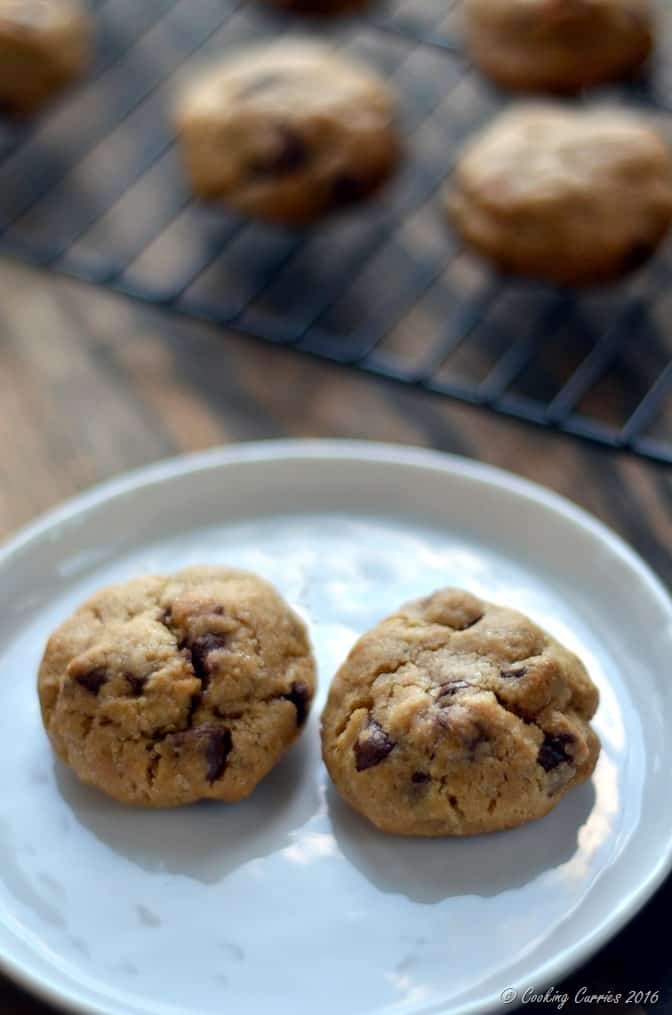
left=444, top=105, right=672, bottom=284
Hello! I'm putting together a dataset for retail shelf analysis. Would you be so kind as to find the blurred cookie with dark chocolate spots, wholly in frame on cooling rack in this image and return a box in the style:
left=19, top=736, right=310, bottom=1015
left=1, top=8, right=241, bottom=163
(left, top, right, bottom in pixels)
left=177, top=42, right=399, bottom=223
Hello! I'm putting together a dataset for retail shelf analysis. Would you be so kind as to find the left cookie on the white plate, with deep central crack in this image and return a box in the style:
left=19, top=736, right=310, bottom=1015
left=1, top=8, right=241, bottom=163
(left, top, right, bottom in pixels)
left=39, top=567, right=316, bottom=807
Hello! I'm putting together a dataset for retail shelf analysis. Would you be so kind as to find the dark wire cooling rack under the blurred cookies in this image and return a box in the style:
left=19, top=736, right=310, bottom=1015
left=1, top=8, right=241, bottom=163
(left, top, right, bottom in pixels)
left=0, top=0, right=672, bottom=463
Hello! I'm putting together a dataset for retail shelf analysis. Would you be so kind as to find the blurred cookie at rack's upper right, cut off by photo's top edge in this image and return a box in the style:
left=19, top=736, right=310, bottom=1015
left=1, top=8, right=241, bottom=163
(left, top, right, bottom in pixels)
left=465, top=0, right=654, bottom=91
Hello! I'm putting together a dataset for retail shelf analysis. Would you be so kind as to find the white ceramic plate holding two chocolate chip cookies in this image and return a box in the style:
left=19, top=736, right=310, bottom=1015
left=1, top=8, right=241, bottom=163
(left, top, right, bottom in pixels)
left=0, top=442, right=672, bottom=1015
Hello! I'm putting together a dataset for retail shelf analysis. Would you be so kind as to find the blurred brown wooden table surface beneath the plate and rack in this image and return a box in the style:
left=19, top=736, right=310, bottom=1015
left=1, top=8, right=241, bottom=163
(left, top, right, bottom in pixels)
left=0, top=261, right=672, bottom=1015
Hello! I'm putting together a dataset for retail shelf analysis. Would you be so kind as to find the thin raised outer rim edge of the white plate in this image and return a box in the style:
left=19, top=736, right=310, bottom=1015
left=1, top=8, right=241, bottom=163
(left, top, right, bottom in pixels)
left=0, top=438, right=672, bottom=1015
